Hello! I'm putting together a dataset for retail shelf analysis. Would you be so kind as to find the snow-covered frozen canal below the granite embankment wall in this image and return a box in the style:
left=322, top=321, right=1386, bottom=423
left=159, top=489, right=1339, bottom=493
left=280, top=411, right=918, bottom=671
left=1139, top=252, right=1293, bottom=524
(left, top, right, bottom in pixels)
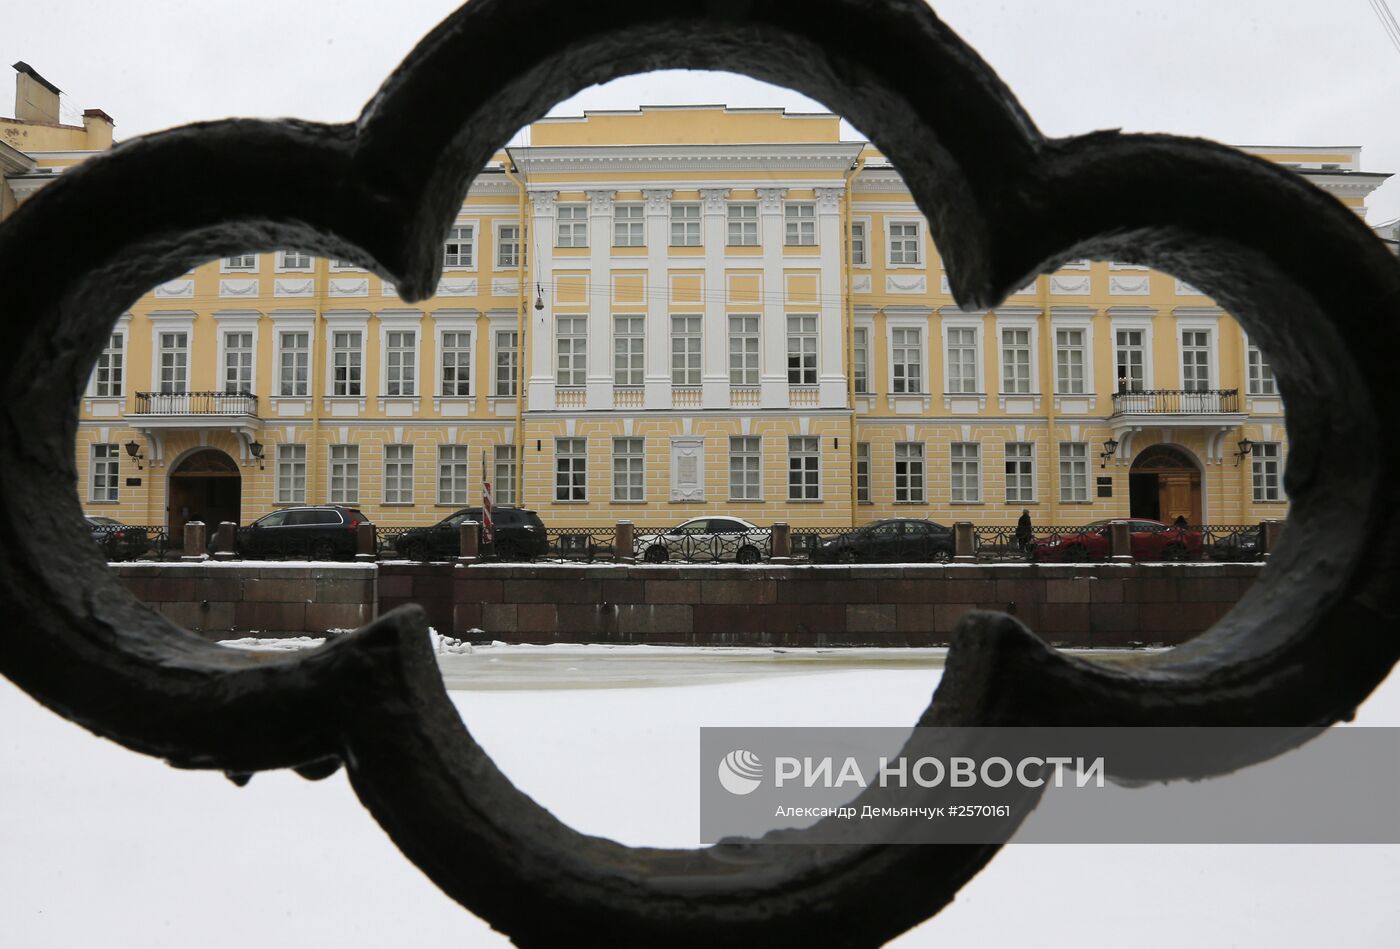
left=0, top=647, right=1400, bottom=949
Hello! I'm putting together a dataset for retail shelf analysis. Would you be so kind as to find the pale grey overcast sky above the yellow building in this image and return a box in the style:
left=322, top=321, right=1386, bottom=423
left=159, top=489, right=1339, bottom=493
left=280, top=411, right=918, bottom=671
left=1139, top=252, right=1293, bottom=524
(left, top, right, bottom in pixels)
left=0, top=0, right=1400, bottom=223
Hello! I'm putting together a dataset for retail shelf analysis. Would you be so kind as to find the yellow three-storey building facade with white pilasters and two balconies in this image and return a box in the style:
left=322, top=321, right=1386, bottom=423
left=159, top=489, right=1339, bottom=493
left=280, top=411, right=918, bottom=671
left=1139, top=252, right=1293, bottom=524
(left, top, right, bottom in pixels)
left=8, top=70, right=1386, bottom=540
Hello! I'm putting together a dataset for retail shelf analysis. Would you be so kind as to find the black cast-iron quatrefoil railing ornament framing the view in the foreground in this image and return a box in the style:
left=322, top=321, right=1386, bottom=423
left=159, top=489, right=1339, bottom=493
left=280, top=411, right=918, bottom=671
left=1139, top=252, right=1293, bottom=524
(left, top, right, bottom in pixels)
left=0, top=0, right=1400, bottom=946
